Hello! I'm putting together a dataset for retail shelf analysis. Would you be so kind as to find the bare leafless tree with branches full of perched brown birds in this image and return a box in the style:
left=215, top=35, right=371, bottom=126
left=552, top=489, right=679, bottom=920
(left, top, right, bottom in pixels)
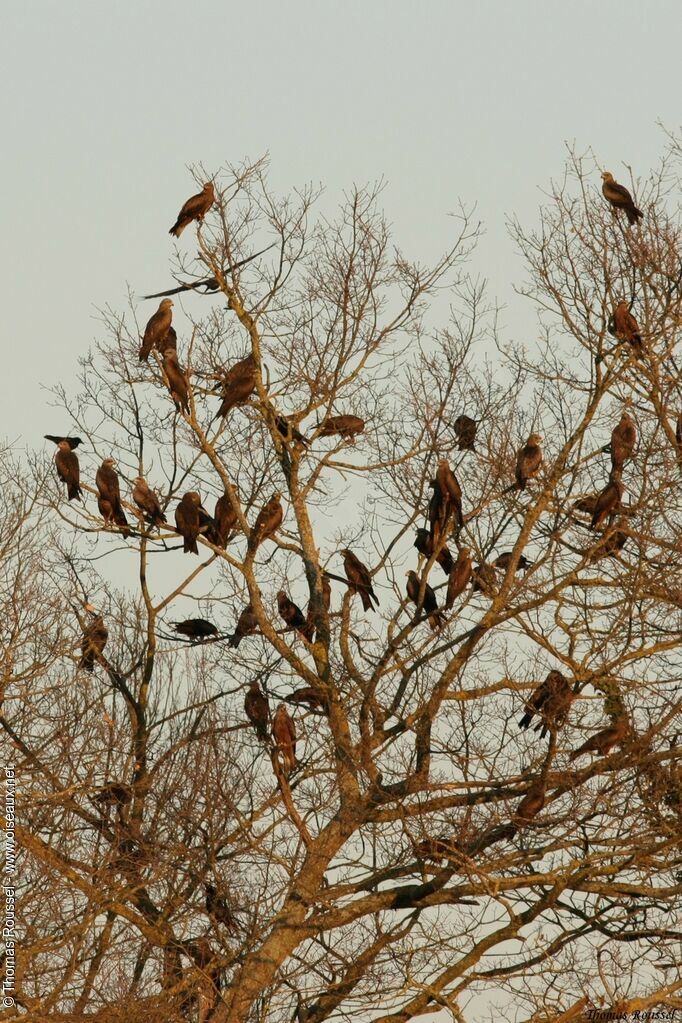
left=3, top=146, right=682, bottom=1023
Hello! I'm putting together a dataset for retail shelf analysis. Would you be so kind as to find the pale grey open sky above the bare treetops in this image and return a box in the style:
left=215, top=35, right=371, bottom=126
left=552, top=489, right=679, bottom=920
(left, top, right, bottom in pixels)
left=0, top=0, right=682, bottom=445
